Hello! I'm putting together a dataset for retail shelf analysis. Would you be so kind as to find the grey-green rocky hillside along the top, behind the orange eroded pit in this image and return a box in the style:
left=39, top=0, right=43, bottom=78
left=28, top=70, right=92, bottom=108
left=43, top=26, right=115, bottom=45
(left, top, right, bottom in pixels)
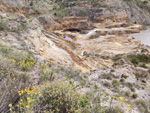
left=1, top=0, right=150, bottom=24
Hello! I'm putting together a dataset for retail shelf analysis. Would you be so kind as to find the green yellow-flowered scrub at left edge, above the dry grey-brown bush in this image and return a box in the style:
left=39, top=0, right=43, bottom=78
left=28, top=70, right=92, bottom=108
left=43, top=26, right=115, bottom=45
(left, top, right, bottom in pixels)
left=0, top=44, right=35, bottom=71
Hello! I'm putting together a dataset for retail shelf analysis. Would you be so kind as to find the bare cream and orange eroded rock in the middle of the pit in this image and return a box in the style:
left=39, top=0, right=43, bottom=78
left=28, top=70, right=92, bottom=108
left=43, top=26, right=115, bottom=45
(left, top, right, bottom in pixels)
left=0, top=13, right=146, bottom=72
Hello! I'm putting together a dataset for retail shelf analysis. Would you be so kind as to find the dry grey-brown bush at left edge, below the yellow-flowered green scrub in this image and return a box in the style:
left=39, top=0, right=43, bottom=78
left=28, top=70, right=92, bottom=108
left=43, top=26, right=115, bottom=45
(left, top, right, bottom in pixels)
left=0, top=58, right=30, bottom=113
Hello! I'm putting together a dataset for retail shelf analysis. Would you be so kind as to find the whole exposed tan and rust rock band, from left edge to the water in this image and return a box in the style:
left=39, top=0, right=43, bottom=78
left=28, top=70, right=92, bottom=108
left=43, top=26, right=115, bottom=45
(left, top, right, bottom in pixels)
left=1, top=2, right=149, bottom=72
